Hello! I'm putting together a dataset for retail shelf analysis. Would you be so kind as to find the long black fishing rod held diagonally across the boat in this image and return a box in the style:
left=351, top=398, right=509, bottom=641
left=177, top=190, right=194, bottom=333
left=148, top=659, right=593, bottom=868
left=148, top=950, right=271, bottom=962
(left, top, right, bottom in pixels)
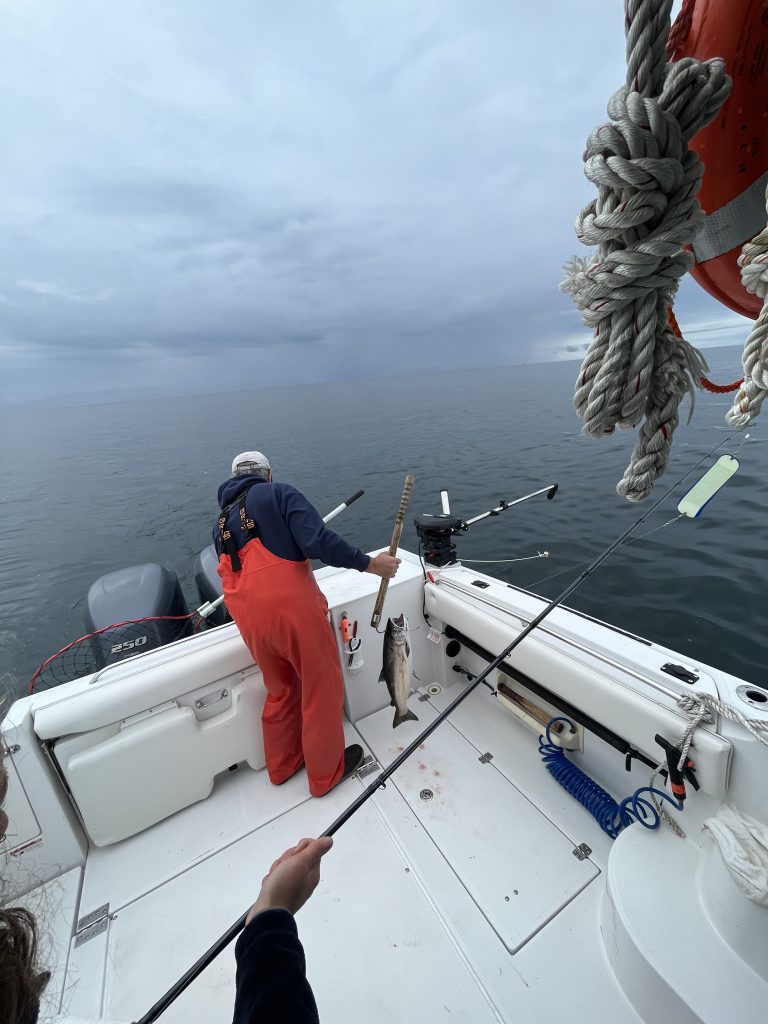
left=135, top=434, right=733, bottom=1024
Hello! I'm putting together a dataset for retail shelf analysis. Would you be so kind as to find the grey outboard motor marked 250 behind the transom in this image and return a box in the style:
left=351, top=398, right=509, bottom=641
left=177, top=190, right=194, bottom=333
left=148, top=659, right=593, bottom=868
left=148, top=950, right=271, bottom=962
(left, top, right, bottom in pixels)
left=83, top=562, right=193, bottom=669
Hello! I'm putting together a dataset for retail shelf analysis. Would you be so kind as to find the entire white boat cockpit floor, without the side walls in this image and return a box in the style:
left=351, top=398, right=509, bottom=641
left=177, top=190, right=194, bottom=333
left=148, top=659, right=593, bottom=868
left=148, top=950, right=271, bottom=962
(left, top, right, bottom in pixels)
left=48, top=691, right=639, bottom=1024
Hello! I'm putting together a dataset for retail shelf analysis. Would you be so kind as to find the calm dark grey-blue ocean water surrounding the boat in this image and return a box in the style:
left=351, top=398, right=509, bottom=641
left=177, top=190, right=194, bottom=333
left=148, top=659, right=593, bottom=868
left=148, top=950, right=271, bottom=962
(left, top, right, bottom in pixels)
left=0, top=348, right=768, bottom=704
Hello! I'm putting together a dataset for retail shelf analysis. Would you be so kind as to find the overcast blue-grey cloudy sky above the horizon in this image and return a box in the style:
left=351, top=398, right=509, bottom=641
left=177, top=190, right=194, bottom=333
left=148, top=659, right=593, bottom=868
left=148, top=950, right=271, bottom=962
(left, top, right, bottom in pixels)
left=0, top=0, right=743, bottom=402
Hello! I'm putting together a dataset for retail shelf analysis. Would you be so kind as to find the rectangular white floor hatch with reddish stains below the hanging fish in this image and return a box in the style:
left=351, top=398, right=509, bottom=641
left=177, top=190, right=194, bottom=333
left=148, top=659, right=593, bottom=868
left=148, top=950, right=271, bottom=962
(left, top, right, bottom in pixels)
left=358, top=697, right=598, bottom=952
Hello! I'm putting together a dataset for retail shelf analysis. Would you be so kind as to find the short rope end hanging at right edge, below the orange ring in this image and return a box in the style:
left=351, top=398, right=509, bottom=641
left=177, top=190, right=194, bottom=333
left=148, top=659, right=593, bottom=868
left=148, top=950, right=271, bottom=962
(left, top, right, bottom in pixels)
left=725, top=190, right=768, bottom=430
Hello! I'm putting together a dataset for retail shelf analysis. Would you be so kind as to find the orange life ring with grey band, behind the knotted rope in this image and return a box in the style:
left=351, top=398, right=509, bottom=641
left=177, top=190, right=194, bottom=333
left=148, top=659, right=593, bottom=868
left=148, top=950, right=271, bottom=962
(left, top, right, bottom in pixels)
left=668, top=0, right=768, bottom=319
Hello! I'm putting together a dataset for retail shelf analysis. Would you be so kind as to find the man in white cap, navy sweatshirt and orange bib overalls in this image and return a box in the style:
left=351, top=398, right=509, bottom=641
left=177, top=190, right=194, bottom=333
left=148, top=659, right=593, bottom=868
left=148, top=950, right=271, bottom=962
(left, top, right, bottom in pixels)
left=214, top=452, right=400, bottom=797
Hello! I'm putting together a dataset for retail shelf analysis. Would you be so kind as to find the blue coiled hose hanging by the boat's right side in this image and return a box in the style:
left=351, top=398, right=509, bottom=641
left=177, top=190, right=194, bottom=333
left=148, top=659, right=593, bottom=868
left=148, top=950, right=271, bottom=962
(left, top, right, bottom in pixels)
left=539, top=718, right=683, bottom=839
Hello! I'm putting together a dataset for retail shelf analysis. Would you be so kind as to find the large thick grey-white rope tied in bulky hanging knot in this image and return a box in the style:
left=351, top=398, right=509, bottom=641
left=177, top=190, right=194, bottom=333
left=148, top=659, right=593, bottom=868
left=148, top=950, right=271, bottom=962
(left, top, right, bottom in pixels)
left=561, top=0, right=731, bottom=501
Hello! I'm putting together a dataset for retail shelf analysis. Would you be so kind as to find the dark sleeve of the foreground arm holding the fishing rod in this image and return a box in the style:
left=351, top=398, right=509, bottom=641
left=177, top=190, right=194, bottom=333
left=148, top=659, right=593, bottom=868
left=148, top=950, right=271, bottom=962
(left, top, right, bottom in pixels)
left=232, top=908, right=319, bottom=1024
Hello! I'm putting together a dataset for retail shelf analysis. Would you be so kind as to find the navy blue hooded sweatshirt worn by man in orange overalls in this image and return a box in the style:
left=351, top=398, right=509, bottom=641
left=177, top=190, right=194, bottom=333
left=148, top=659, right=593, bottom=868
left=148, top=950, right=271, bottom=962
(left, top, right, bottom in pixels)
left=213, top=476, right=370, bottom=572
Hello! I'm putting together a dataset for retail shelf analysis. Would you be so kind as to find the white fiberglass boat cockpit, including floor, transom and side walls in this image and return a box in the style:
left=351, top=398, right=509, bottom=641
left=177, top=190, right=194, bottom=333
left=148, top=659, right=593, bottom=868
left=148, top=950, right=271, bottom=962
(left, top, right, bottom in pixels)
left=4, top=553, right=768, bottom=1024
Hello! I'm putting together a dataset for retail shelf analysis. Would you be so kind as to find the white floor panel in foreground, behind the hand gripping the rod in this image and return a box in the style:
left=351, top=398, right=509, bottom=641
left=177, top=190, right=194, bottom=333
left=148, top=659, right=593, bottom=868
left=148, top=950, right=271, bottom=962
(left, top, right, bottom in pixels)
left=71, top=782, right=505, bottom=1024
